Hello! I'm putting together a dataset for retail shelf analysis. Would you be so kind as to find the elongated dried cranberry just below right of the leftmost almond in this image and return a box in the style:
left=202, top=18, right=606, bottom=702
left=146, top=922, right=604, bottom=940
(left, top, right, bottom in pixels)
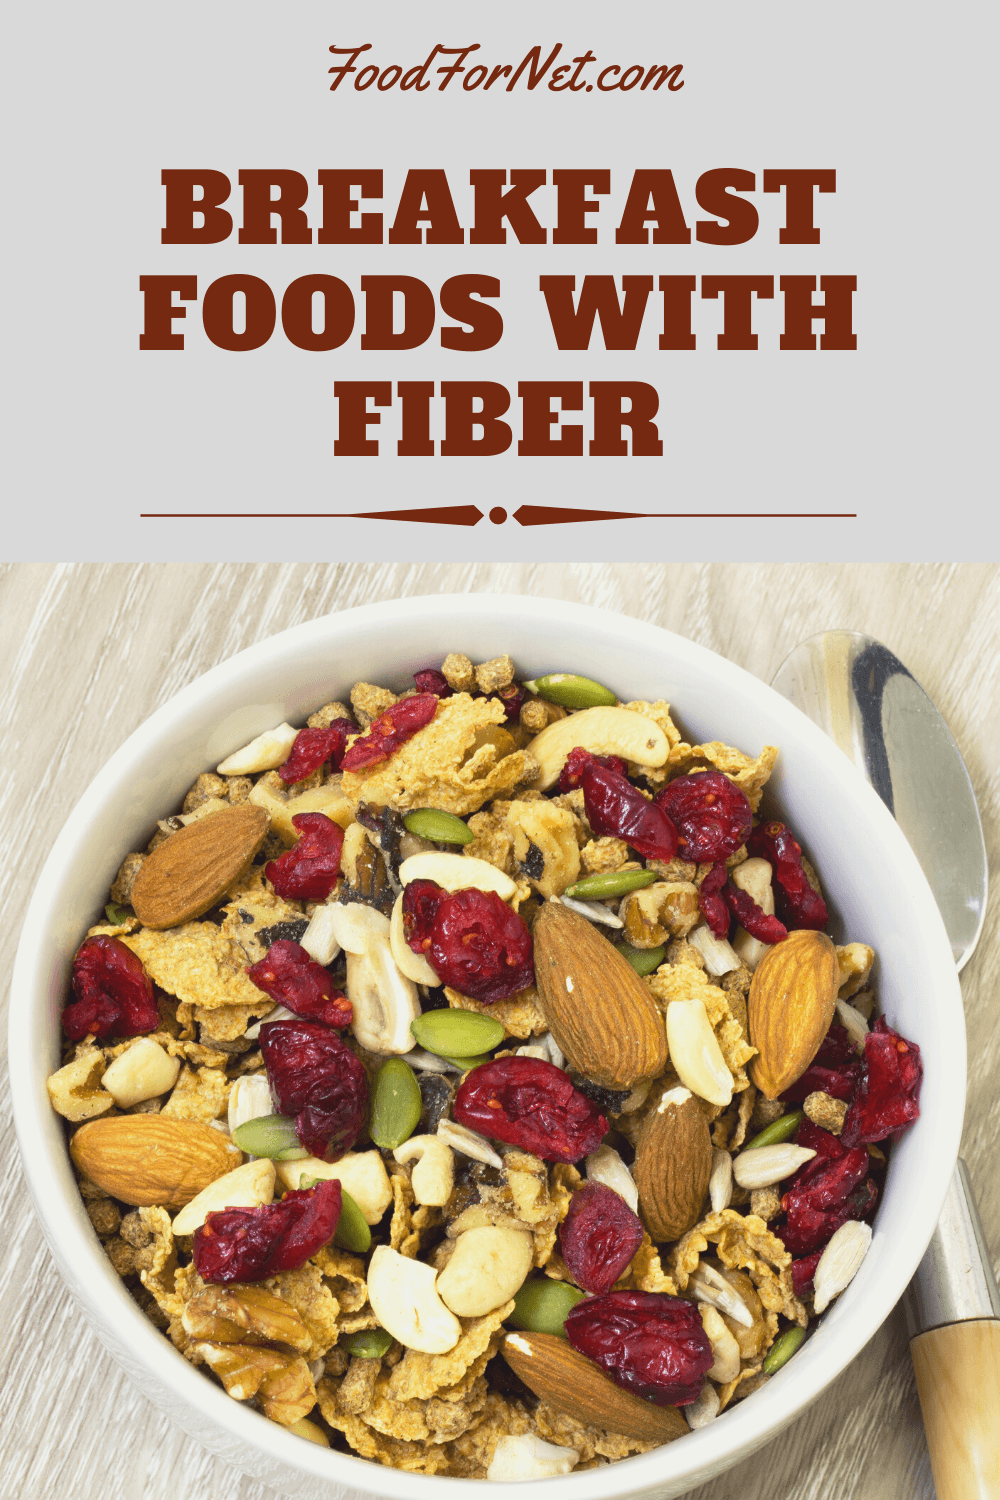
left=192, top=1178, right=342, bottom=1286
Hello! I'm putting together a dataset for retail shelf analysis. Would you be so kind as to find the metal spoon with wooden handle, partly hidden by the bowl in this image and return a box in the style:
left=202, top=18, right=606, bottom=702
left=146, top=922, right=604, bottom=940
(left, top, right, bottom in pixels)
left=771, top=630, right=1000, bottom=1500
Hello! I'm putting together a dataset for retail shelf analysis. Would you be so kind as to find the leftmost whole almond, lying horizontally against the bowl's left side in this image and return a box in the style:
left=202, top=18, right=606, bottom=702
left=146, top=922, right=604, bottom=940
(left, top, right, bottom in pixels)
left=69, top=1115, right=241, bottom=1209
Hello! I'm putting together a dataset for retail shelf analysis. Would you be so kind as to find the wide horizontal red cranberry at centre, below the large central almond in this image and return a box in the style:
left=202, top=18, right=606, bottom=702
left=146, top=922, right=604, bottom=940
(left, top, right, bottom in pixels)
left=453, top=1058, right=607, bottom=1161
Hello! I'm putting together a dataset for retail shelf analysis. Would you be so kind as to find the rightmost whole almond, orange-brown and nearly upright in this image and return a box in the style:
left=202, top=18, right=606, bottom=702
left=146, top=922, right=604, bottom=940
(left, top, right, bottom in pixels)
left=747, top=929, right=840, bottom=1100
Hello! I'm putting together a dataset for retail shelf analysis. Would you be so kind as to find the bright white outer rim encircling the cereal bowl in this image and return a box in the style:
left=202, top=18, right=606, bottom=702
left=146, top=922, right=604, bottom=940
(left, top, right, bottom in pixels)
left=9, top=594, right=966, bottom=1500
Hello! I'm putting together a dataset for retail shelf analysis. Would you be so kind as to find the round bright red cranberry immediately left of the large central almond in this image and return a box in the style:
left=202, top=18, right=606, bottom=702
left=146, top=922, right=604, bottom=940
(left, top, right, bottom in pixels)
left=425, top=887, right=535, bottom=1005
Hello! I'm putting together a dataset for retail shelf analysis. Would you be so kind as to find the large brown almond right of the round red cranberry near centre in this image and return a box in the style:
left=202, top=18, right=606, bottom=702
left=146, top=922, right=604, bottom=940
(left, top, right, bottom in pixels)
left=532, top=902, right=667, bottom=1089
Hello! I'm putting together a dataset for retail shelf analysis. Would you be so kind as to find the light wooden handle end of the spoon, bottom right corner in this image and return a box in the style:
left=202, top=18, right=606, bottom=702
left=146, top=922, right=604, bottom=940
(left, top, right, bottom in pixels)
left=910, top=1319, right=1000, bottom=1500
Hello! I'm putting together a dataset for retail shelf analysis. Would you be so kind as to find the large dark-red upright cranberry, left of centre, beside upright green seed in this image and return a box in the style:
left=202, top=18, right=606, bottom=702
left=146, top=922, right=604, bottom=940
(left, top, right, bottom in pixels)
left=261, top=1022, right=369, bottom=1161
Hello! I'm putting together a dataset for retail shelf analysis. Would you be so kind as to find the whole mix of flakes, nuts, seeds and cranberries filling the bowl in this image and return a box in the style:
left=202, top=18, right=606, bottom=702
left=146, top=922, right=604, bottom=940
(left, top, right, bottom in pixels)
left=48, top=653, right=921, bottom=1479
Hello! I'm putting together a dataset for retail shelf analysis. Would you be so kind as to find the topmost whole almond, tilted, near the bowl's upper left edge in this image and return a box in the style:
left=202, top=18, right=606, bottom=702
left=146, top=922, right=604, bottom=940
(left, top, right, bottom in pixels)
left=132, top=803, right=268, bottom=927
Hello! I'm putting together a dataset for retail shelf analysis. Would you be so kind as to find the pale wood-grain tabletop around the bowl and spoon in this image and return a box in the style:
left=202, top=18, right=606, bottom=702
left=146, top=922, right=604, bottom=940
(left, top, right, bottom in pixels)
left=0, top=563, right=1000, bottom=1500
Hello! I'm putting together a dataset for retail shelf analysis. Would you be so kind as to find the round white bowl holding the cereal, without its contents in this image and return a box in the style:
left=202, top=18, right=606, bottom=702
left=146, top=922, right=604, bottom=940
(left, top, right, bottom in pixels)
left=10, top=594, right=966, bottom=1500
